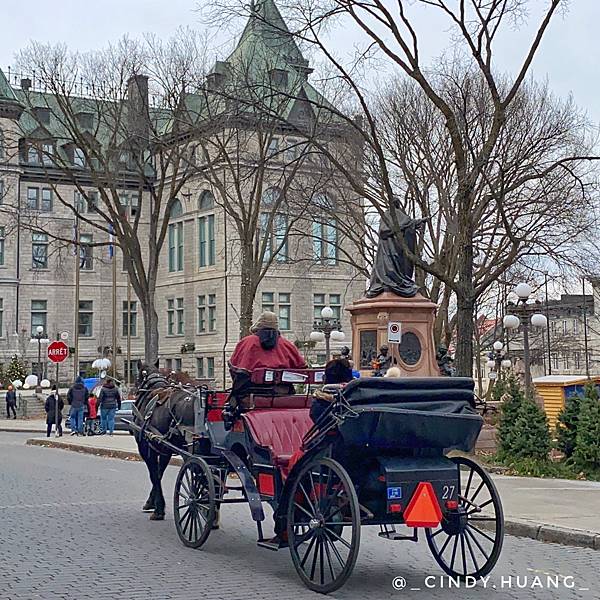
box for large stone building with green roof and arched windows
[0,0,365,383]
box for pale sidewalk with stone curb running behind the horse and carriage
[11,428,600,550]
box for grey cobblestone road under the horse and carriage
[0,433,600,600]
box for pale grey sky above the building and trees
[0,0,600,121]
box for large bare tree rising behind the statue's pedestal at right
[209,0,595,375]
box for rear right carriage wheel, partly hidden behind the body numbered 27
[425,457,504,578]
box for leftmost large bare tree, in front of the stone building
[8,30,211,362]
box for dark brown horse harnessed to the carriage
[133,361,194,521]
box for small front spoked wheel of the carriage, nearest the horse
[173,457,217,548]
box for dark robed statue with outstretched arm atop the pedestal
[367,202,427,298]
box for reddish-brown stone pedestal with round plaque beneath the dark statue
[346,292,440,377]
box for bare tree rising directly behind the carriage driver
[188,14,358,336]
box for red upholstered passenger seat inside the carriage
[242,408,313,474]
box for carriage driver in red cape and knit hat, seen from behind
[229,310,306,409]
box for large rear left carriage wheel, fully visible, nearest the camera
[287,458,360,594]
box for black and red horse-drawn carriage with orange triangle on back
[130,369,504,593]
